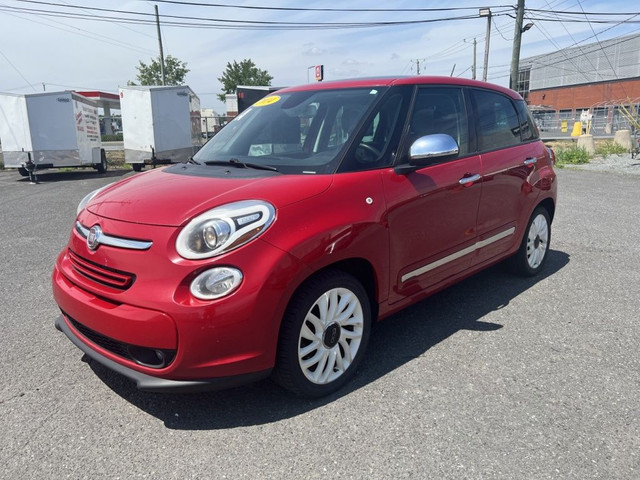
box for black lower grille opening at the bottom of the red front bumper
[65,313,176,368]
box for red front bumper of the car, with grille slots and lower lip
[52,211,306,391]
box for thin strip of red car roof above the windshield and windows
[278,76,522,100]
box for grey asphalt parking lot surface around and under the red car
[0,166,640,479]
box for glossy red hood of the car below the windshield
[86,165,332,227]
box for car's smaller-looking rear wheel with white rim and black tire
[509,207,551,277]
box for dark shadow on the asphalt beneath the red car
[90,250,570,430]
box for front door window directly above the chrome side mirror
[409,87,469,156]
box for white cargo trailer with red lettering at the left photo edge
[0,91,107,176]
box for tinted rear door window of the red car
[473,90,521,151]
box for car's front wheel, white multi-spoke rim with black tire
[273,270,371,398]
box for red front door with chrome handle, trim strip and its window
[384,86,482,303]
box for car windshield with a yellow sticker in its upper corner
[194,87,385,174]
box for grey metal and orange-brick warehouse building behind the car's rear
[518,34,640,134]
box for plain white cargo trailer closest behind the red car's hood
[120,85,202,171]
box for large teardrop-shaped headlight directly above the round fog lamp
[176,200,275,260]
